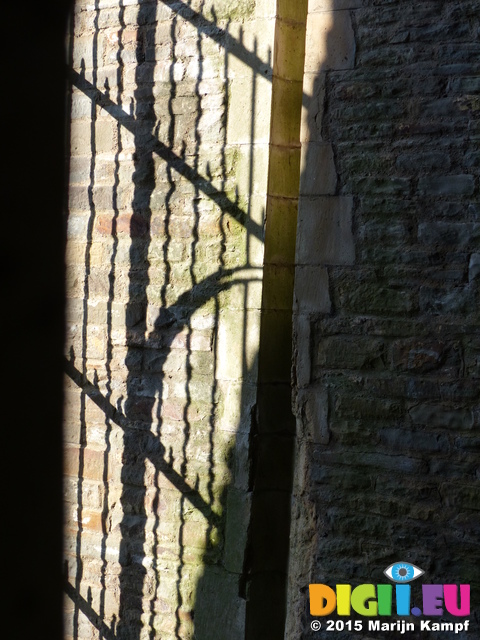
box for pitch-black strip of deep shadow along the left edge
[1,2,70,640]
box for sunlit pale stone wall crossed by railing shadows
[66,0,270,640]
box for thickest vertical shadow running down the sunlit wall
[117,2,157,640]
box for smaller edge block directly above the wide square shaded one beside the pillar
[300,140,337,196]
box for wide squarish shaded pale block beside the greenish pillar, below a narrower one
[296,196,355,265]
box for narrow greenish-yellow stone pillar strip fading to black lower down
[246,0,307,640]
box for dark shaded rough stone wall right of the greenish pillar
[286,0,480,638]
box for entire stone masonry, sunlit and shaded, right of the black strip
[64,0,480,640]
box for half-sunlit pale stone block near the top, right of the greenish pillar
[305,10,355,73]
